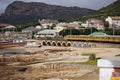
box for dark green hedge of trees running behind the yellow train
[59,28,120,36]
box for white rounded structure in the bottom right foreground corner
[97,57,120,80]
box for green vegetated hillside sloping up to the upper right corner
[79,0,120,20]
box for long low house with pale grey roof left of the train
[34,29,59,38]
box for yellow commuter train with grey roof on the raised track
[65,35,120,43]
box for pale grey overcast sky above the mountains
[0,0,116,13]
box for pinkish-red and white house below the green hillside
[86,19,104,30]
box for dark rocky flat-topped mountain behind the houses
[0,1,95,24]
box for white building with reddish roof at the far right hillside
[105,16,120,28]
